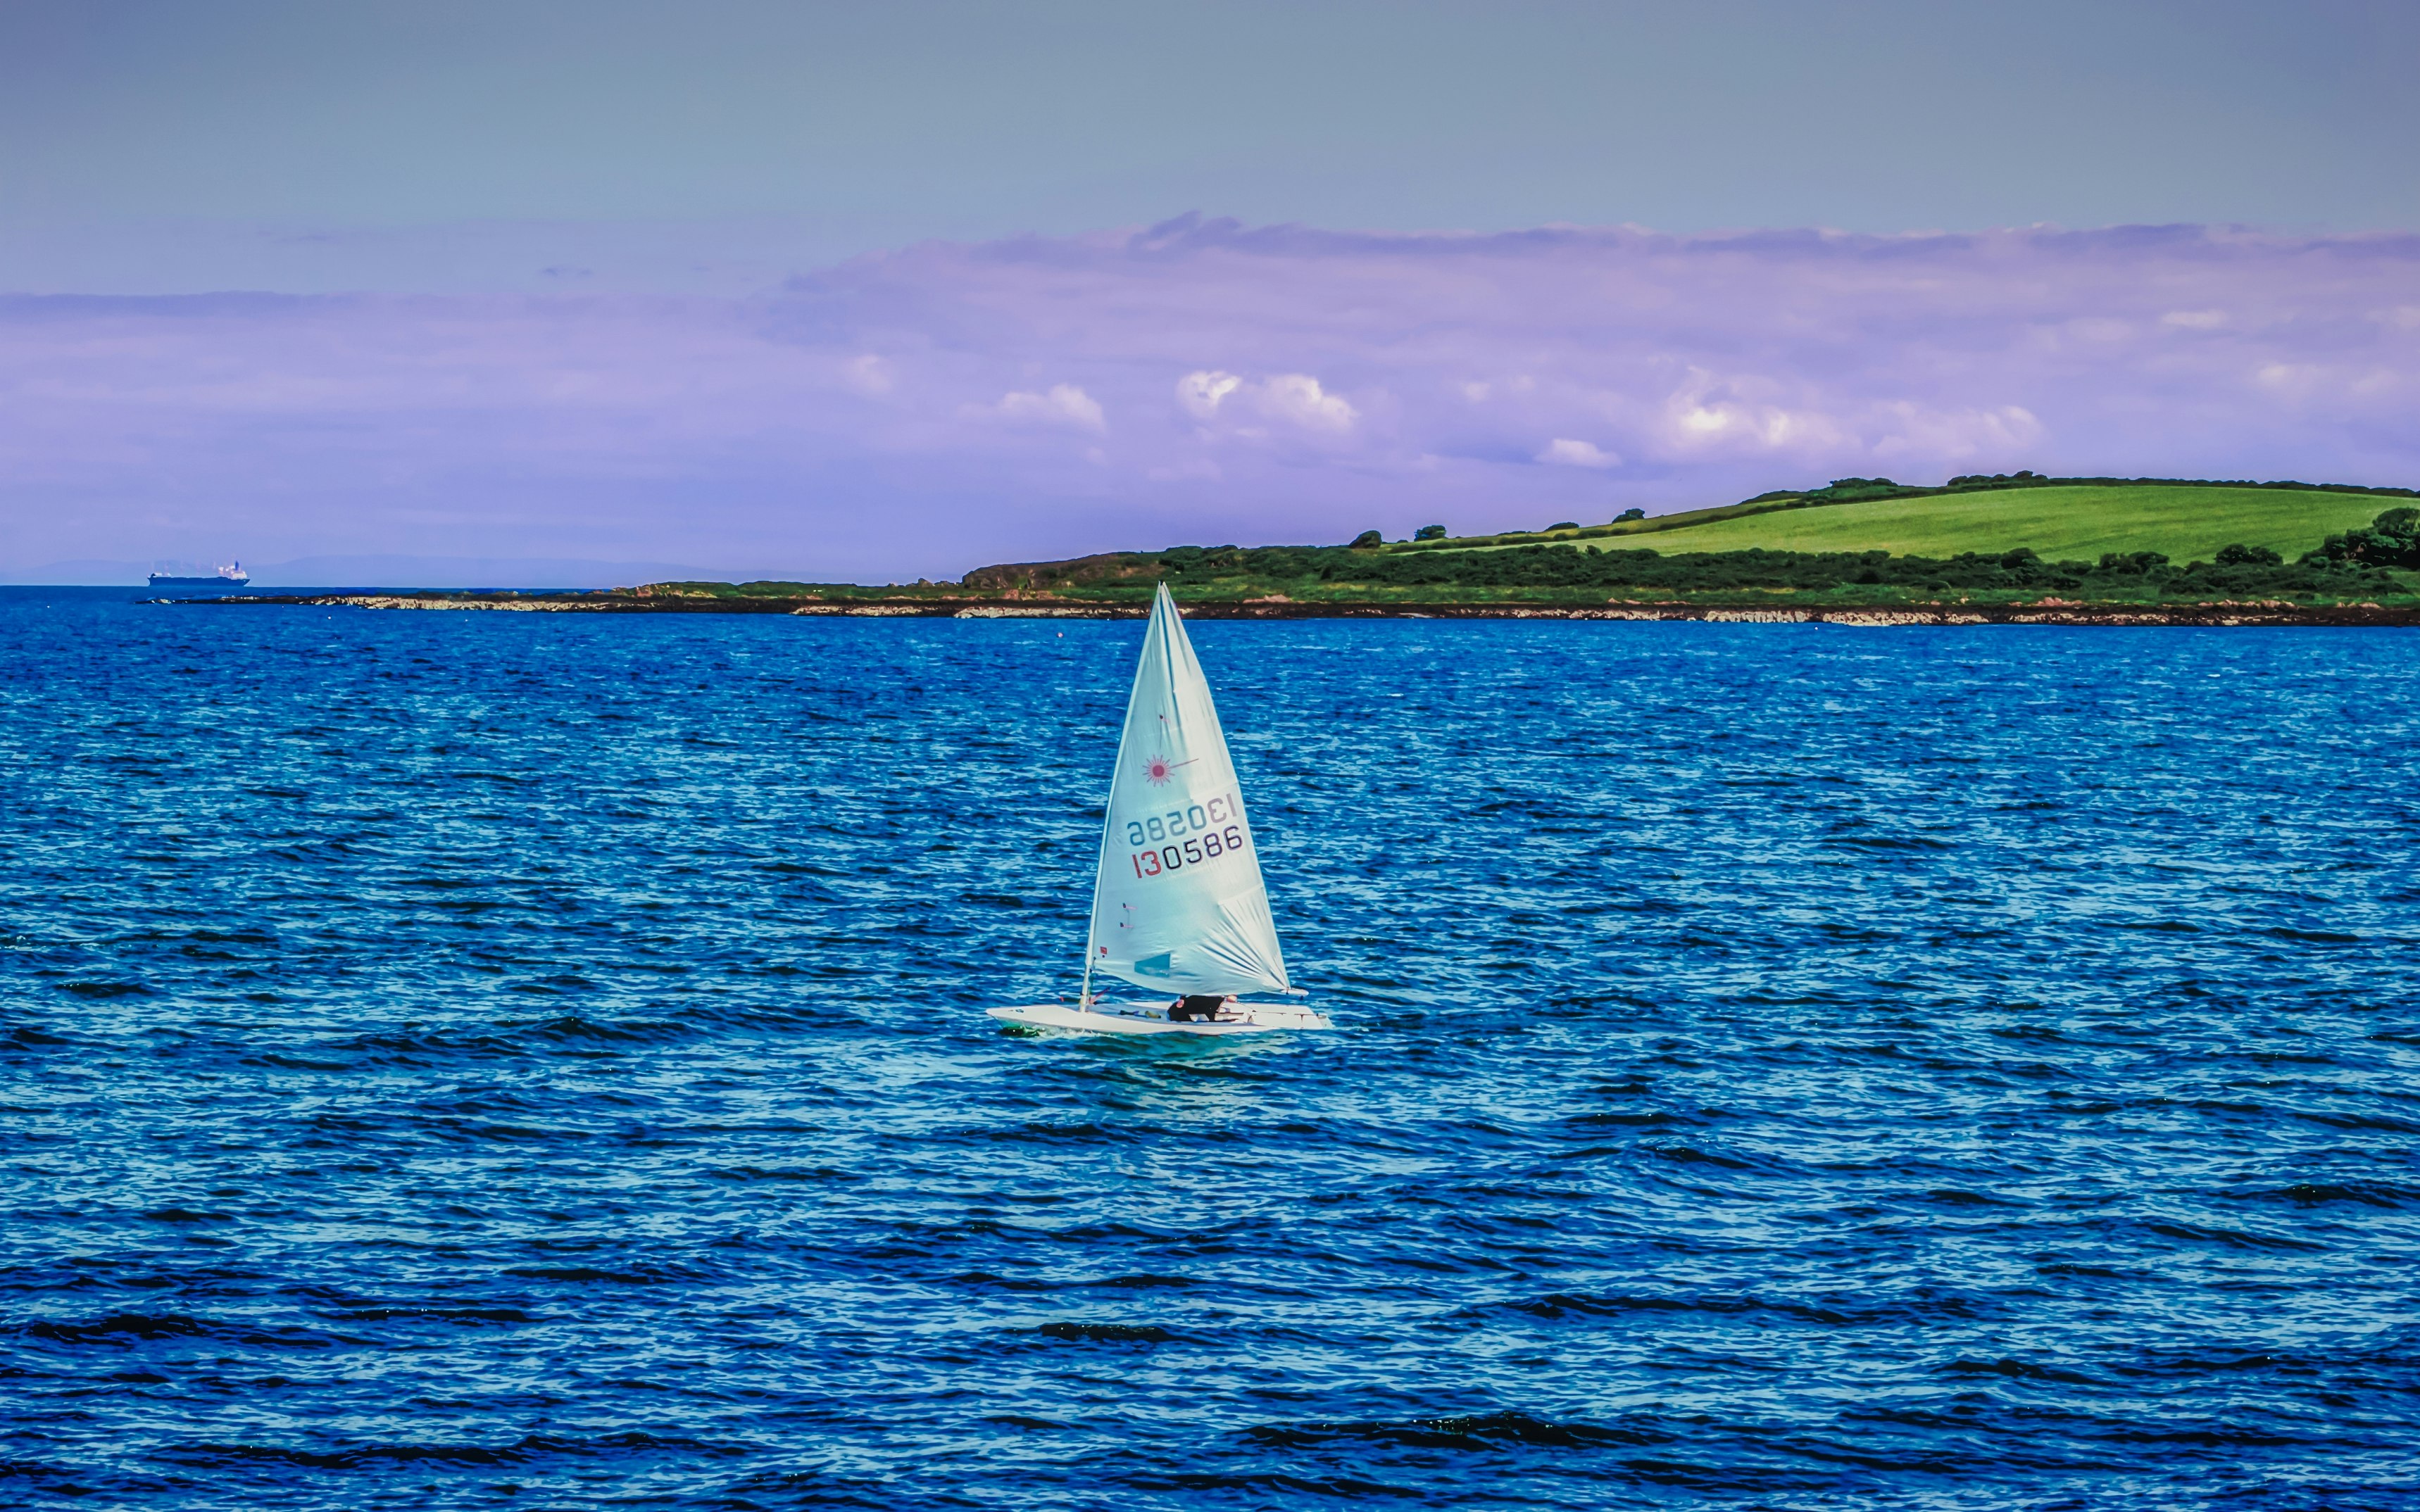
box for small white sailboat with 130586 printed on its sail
[985,583,1336,1035]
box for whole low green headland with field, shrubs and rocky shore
[196,472,2420,624]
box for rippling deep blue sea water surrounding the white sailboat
[0,591,2420,1510]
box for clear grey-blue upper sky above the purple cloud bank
[0,0,2420,293]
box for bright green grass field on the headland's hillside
[1529,486,2405,564]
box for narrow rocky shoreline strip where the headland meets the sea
[184,593,2420,626]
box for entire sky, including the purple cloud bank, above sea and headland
[0,0,2420,578]
